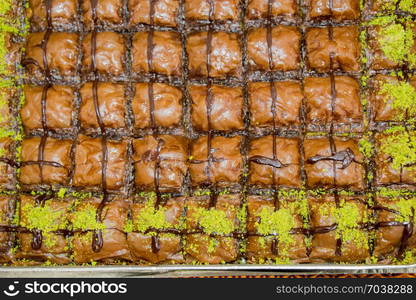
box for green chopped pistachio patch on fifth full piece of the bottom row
[256,207,295,245]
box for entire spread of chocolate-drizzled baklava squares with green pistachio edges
[0,0,416,268]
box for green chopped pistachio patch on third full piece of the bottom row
[133,200,172,232]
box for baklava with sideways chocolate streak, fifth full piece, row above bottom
[248,136,301,187]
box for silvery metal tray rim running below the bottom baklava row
[0,264,416,278]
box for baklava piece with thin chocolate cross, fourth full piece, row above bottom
[189,136,243,186]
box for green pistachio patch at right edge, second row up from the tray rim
[380,126,416,170]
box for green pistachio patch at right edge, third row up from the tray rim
[380,81,416,121]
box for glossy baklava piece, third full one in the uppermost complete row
[132,31,182,76]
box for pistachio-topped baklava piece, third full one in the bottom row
[127,197,185,264]
